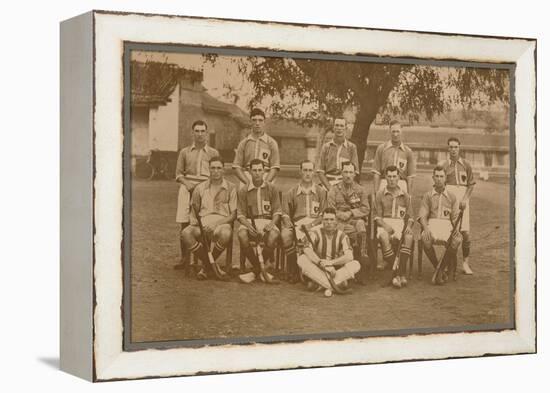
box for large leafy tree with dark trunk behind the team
[209,57,509,172]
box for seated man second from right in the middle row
[374,165,414,288]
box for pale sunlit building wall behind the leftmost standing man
[149,83,179,151]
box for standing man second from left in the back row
[233,108,281,187]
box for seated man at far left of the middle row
[181,157,237,280]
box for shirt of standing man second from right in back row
[372,141,416,180]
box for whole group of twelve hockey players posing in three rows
[176,108,475,289]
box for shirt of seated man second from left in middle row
[237,182,282,219]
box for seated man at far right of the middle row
[418,166,462,284]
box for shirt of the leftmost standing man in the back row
[176,144,220,182]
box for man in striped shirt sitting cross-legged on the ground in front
[298,207,361,296]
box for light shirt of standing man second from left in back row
[233,133,281,170]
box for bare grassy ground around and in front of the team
[131,175,512,342]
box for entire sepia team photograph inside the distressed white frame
[125,48,515,346]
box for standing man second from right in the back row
[372,120,416,195]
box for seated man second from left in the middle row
[237,159,282,283]
